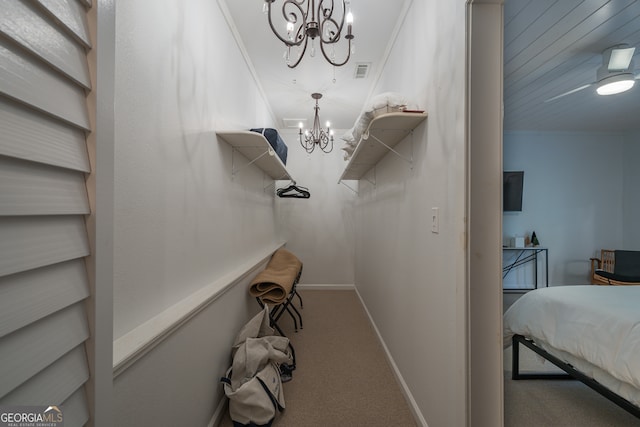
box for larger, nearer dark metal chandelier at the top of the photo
[263,0,354,68]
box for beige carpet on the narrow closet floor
[220,290,416,427]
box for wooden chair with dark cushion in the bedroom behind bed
[590,249,640,285]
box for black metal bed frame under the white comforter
[511,334,640,418]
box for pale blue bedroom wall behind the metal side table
[503,132,640,285]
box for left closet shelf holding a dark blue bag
[216,130,293,181]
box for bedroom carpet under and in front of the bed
[504,346,640,427]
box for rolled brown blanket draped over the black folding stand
[249,249,302,304]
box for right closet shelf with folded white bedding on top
[339,112,427,181]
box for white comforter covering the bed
[504,285,640,404]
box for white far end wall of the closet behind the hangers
[276,129,355,285]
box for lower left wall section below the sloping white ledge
[112,277,257,427]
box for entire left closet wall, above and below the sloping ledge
[110,0,281,426]
